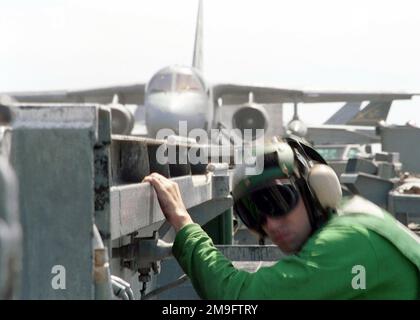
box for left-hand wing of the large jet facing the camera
[5,84,145,105]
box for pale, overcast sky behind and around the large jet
[0,0,420,124]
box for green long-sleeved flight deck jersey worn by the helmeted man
[173,197,420,299]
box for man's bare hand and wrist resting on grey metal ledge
[143,172,193,232]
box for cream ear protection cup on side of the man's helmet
[308,164,342,209]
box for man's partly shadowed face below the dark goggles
[262,197,311,253]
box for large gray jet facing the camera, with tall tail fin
[2,0,412,138]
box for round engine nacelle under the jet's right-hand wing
[232,104,268,140]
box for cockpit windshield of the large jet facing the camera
[148,70,205,93]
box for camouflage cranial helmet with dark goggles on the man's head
[232,138,334,236]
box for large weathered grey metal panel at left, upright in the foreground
[11,106,97,299]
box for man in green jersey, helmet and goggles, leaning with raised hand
[144,139,420,299]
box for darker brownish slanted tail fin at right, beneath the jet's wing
[347,101,392,126]
